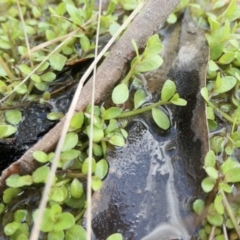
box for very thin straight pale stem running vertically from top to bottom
[87,0,102,240]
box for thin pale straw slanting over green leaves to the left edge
[0,31,76,103]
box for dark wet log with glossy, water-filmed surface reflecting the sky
[89,11,209,240]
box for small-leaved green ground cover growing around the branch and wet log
[0,0,240,240]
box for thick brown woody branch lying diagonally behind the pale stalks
[0,0,180,191]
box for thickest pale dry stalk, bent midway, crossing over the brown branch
[30,1,145,240]
